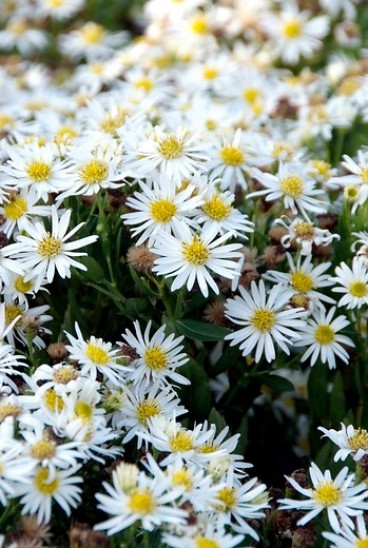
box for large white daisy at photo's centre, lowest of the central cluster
[151,223,243,297]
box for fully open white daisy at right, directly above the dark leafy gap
[225,280,305,362]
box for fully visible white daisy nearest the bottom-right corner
[279,462,368,533]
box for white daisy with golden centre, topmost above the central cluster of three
[129,126,208,184]
